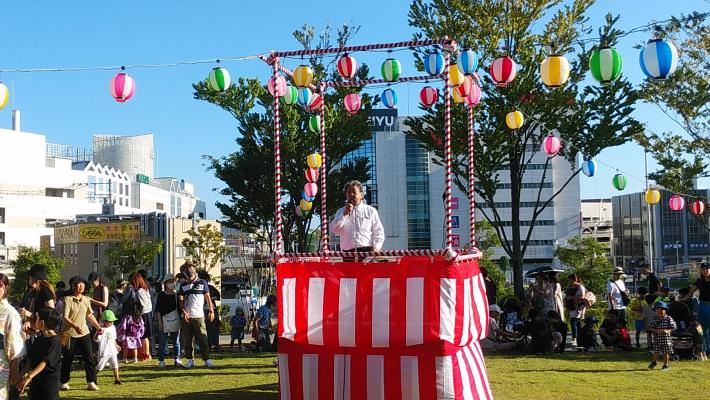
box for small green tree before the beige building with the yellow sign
[105,239,164,281]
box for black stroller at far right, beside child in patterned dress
[668,301,703,360]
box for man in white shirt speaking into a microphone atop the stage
[331,181,385,258]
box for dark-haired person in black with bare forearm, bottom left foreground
[17,308,62,400]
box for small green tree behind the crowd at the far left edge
[10,246,66,301]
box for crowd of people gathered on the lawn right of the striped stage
[481,263,710,371]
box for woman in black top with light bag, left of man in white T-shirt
[155,274,182,368]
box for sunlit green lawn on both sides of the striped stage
[60,352,710,400]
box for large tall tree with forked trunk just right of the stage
[407,0,642,298]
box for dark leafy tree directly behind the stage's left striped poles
[193,25,375,251]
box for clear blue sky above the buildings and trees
[0,0,710,218]
